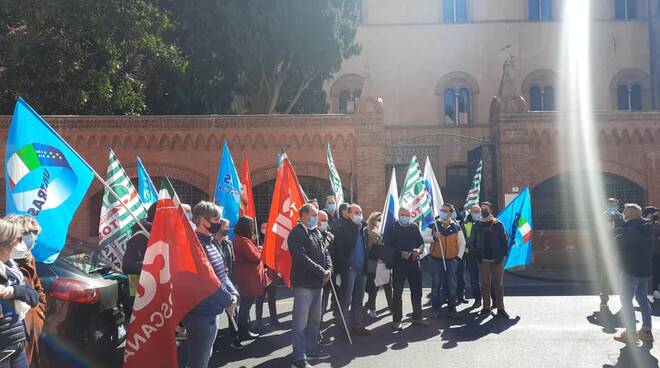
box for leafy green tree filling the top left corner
[0,0,186,114]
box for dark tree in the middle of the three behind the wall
[148,0,239,114]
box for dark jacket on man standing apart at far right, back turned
[615,218,654,277]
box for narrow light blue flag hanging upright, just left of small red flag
[214,141,241,239]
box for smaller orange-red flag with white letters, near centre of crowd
[261,156,305,287]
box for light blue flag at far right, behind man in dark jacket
[497,188,532,269]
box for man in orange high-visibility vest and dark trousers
[429,203,465,319]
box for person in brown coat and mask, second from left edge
[6,215,46,367]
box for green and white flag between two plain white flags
[399,156,433,229]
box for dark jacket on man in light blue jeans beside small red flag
[287,224,332,289]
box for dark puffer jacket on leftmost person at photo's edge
[0,264,39,351]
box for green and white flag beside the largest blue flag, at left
[99,149,147,269]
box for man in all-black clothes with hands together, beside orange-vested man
[384,207,429,330]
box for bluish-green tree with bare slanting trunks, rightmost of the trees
[220,0,360,114]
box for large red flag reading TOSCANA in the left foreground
[123,190,220,368]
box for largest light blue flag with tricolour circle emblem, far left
[5,97,94,263]
